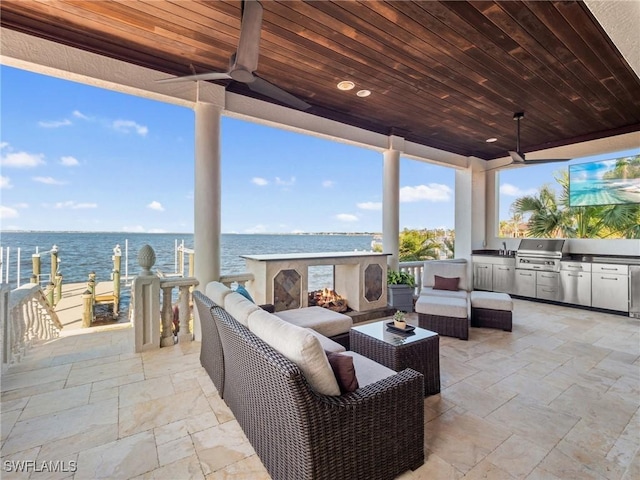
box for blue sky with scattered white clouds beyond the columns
[0,66,636,233]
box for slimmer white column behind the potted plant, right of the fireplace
[382,149,400,270]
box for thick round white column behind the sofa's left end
[193,102,222,340]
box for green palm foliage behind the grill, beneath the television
[513,171,640,238]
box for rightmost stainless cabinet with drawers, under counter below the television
[591,263,629,312]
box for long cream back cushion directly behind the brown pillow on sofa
[249,310,340,395]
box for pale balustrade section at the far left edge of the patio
[0,284,62,370]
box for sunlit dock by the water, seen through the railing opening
[54,281,129,333]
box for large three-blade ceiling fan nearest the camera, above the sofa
[158,0,311,110]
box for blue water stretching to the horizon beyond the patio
[0,232,373,294]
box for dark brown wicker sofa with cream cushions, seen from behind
[194,284,424,480]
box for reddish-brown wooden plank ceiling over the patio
[0,0,640,159]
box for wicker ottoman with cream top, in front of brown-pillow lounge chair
[416,295,469,340]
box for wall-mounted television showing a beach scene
[569,155,640,207]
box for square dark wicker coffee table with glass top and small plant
[349,320,440,396]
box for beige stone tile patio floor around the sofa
[1,300,640,480]
